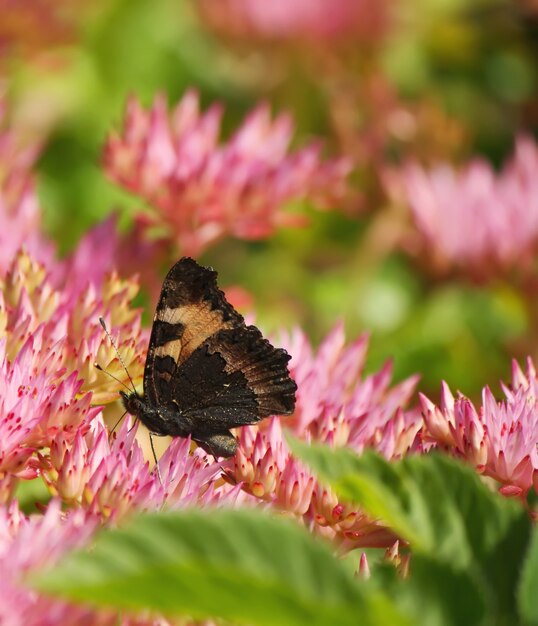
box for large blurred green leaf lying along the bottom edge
[33,509,409,626]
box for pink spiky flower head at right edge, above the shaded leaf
[421,360,538,497]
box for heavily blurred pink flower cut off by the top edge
[196,0,389,42]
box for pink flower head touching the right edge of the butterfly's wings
[282,323,422,458]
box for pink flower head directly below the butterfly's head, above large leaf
[40,420,230,521]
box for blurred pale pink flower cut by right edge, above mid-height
[385,137,538,277]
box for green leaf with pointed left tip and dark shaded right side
[290,441,530,624]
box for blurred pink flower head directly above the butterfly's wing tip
[104,91,350,256]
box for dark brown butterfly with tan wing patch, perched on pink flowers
[120,257,297,457]
